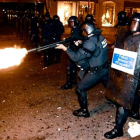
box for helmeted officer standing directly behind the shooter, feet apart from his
[61,16,83,90]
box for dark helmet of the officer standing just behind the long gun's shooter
[68,16,79,28]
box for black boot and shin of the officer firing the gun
[73,87,90,118]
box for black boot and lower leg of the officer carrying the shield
[104,107,129,139]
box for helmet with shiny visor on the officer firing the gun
[81,21,96,37]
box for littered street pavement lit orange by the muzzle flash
[0,20,140,140]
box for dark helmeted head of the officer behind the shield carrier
[114,11,128,27]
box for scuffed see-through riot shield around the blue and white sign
[105,36,140,109]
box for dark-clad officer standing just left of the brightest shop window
[52,15,64,63]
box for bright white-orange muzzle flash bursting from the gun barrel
[0,47,27,69]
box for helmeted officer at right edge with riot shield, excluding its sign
[104,13,140,139]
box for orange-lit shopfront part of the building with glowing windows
[47,0,140,27]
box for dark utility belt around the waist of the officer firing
[88,61,109,74]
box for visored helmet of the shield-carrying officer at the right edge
[131,13,140,33]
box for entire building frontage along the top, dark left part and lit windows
[0,0,140,27]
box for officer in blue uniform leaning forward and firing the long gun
[57,21,109,117]
